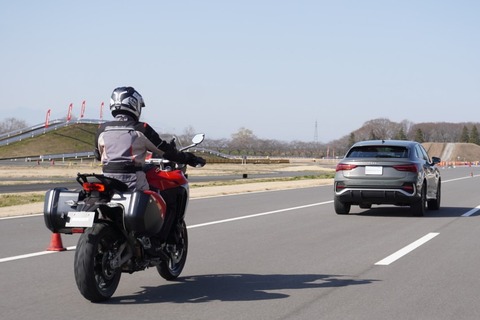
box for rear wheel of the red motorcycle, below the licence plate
[74,223,122,302]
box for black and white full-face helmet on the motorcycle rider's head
[110,87,145,120]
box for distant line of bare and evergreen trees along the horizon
[0,118,480,158]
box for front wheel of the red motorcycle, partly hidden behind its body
[157,221,188,281]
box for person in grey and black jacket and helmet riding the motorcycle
[95,87,206,242]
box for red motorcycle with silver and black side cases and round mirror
[44,134,205,302]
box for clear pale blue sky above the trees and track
[0,0,480,142]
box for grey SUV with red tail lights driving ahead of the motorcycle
[334,140,441,216]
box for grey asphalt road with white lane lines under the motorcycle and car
[0,168,480,320]
